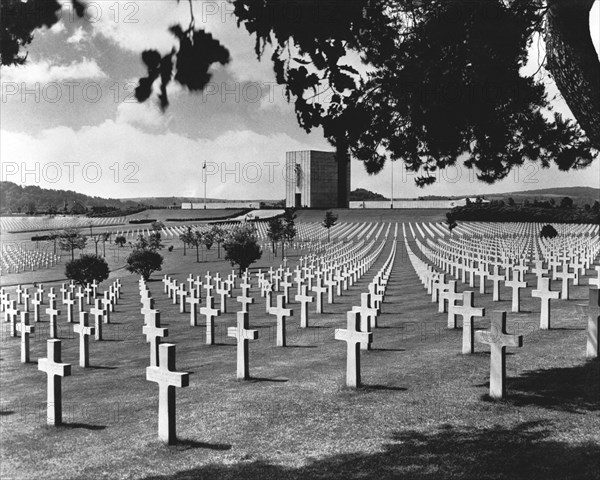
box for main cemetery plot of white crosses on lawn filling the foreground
[0,218,600,479]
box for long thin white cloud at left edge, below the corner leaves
[1,58,106,84]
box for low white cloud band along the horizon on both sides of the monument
[0,120,600,199]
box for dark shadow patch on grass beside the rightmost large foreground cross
[507,360,600,413]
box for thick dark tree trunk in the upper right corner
[546,0,600,149]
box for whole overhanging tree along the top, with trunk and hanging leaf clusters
[2,0,600,186]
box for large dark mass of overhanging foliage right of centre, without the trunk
[229,0,599,186]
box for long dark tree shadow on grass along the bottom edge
[146,422,600,480]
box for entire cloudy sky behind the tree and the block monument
[0,0,600,199]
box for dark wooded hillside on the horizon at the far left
[0,182,138,213]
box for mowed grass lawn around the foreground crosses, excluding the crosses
[0,224,600,480]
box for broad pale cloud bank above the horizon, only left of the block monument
[0,124,310,199]
